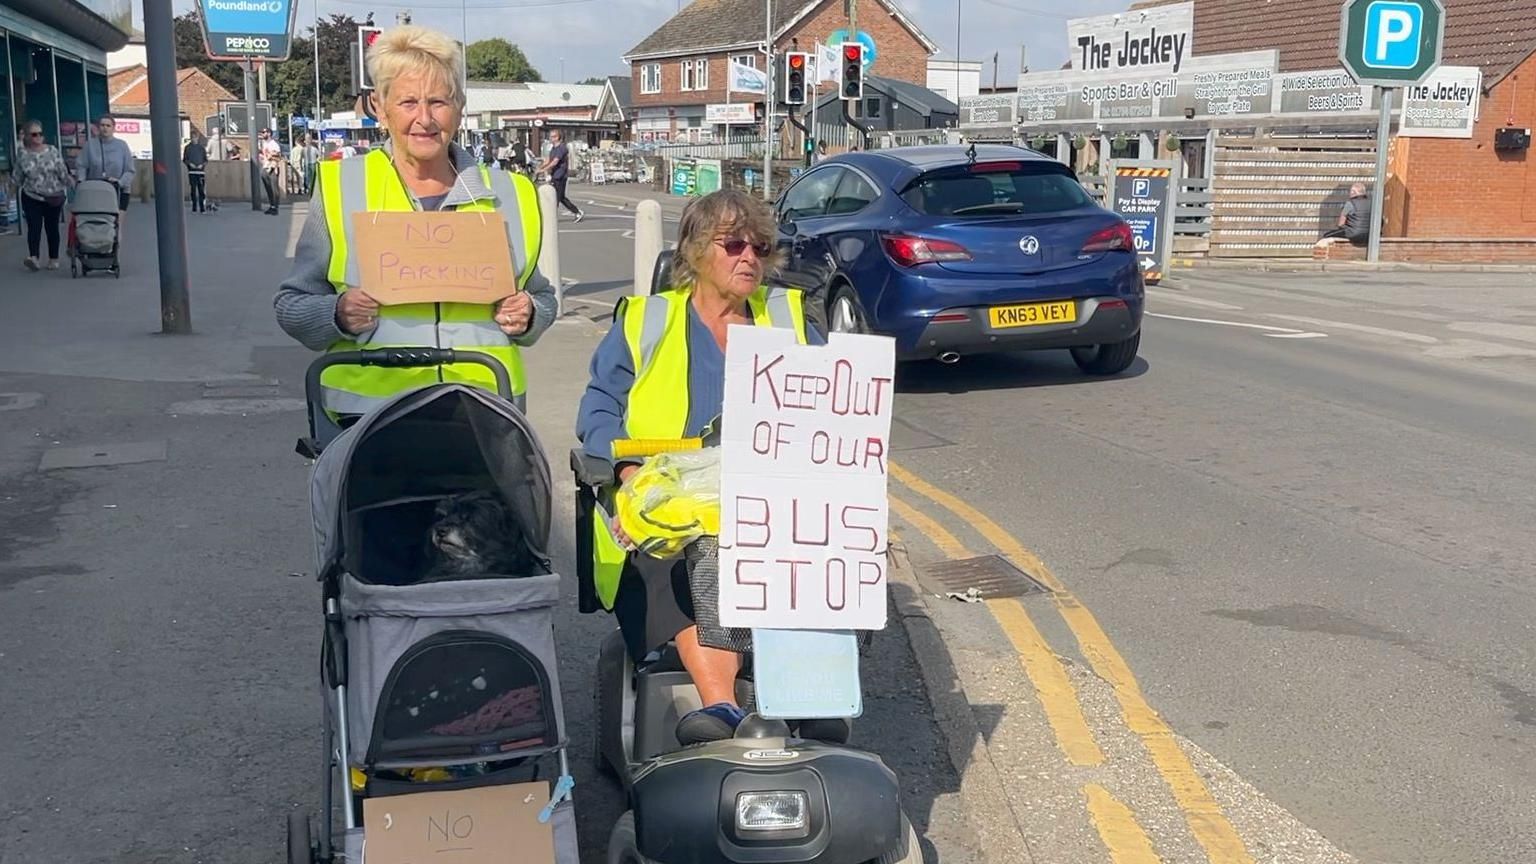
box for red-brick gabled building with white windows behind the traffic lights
[624,0,937,141]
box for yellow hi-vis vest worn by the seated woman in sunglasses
[591,286,806,610]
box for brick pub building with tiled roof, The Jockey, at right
[1130,0,1536,261]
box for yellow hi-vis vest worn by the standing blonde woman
[318,149,544,414]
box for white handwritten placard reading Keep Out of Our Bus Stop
[720,326,895,630]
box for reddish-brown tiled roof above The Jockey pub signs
[1132,0,1536,86]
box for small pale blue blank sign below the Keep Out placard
[753,629,863,719]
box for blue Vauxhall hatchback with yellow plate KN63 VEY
[776,145,1146,375]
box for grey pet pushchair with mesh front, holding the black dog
[289,349,578,864]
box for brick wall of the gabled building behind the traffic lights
[630,0,928,108]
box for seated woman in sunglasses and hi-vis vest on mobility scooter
[576,189,823,744]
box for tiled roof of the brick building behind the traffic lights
[625,0,937,58]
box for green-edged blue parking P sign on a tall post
[1339,0,1445,88]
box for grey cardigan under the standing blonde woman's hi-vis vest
[272,143,559,351]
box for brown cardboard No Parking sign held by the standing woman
[352,211,518,306]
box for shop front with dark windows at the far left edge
[0,0,132,231]
